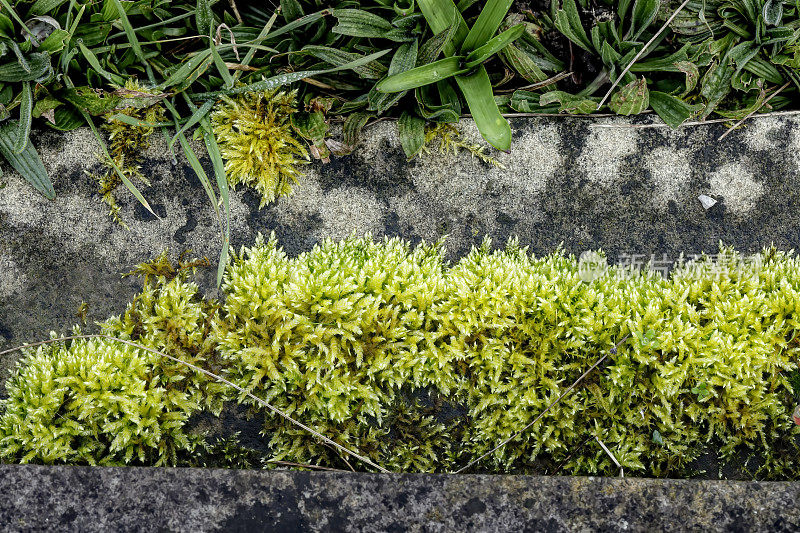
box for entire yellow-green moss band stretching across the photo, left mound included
[0,236,800,479]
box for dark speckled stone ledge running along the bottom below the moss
[0,465,800,531]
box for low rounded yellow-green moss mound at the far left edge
[0,339,200,465]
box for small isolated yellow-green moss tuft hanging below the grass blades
[211,90,308,207]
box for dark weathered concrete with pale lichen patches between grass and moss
[0,117,800,379]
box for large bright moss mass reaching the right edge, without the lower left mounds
[215,238,800,475]
